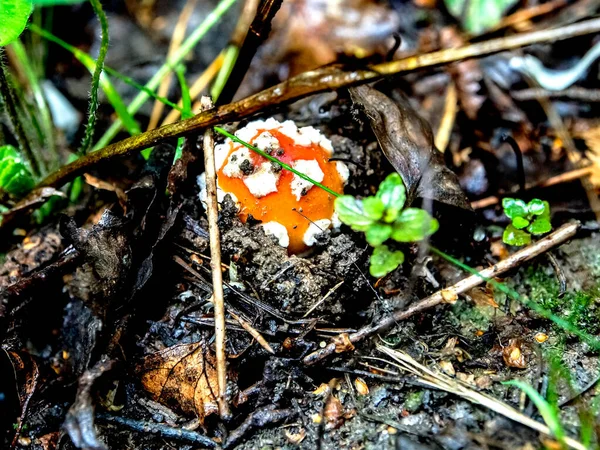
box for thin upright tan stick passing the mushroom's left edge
[204,97,231,419]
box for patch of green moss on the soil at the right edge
[524,266,600,334]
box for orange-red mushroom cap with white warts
[201,118,348,253]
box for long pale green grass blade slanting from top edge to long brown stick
[94,0,236,150]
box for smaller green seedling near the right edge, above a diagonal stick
[502,198,552,246]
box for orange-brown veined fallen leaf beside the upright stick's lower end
[138,342,227,423]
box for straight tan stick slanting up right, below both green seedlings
[303,223,579,365]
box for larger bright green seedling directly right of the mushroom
[335,173,439,277]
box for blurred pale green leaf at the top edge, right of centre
[444,0,517,34]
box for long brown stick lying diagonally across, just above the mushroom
[40,18,600,187]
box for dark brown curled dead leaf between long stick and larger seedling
[349,86,471,211]
